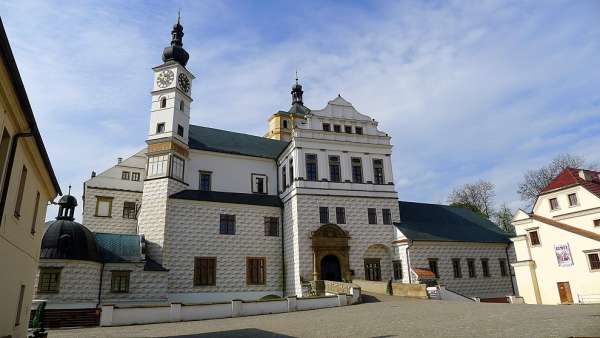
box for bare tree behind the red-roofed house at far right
[517,154,594,207]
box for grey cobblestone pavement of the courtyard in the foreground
[49,296,600,338]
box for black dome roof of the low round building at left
[40,219,100,262]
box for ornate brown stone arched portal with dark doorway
[311,224,352,281]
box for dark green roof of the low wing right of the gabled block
[396,201,510,243]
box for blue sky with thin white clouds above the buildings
[0,0,600,218]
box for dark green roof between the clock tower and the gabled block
[188,125,289,160]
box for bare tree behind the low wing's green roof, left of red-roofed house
[448,180,496,218]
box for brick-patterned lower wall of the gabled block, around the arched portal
[286,195,400,288]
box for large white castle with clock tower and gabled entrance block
[32,17,512,326]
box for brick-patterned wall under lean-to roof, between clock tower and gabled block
[164,199,283,293]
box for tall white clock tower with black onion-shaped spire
[138,16,194,267]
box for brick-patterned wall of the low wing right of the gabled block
[410,243,513,298]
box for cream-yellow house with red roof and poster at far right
[512,168,600,304]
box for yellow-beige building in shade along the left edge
[0,20,60,337]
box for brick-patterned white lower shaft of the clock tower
[138,178,187,263]
